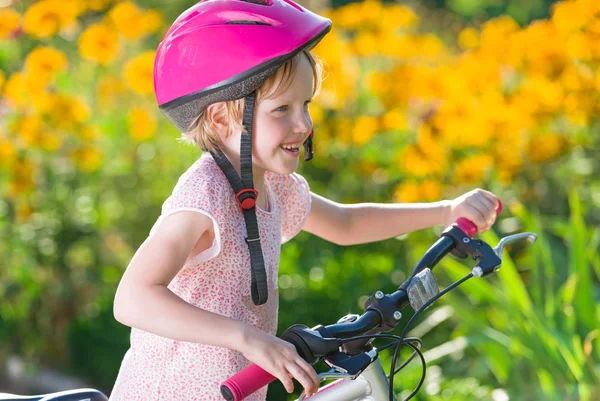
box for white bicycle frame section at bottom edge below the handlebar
[296,358,396,401]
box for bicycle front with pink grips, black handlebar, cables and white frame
[221,204,537,401]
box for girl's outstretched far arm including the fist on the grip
[303,189,498,245]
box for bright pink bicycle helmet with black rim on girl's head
[154,0,331,132]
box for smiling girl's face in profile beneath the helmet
[252,55,313,174]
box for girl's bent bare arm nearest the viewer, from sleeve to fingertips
[114,211,319,394]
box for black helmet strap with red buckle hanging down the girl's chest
[211,92,268,305]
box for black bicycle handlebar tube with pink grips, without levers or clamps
[221,200,502,401]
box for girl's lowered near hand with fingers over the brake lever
[239,326,319,397]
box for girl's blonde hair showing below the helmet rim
[181,50,323,152]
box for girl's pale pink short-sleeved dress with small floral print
[110,153,310,401]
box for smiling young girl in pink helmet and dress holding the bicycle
[111,0,498,401]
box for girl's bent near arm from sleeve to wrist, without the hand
[114,211,243,348]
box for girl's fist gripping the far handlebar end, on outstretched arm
[443,188,499,232]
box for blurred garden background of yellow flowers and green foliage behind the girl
[0,0,600,401]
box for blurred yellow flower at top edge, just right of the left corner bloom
[23,0,79,38]
